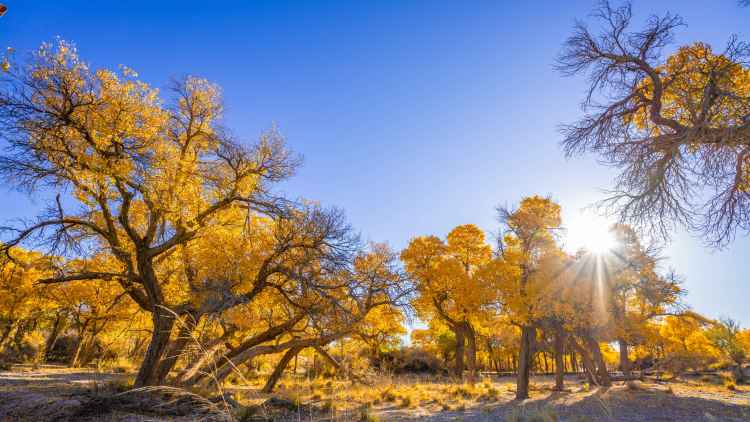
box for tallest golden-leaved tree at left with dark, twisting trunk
[0,41,298,386]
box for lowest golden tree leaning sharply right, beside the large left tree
[182,245,408,389]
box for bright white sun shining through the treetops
[565,214,616,255]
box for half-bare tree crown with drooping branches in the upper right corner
[558,2,750,246]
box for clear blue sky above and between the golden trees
[0,0,750,325]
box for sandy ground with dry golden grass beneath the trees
[0,366,750,422]
